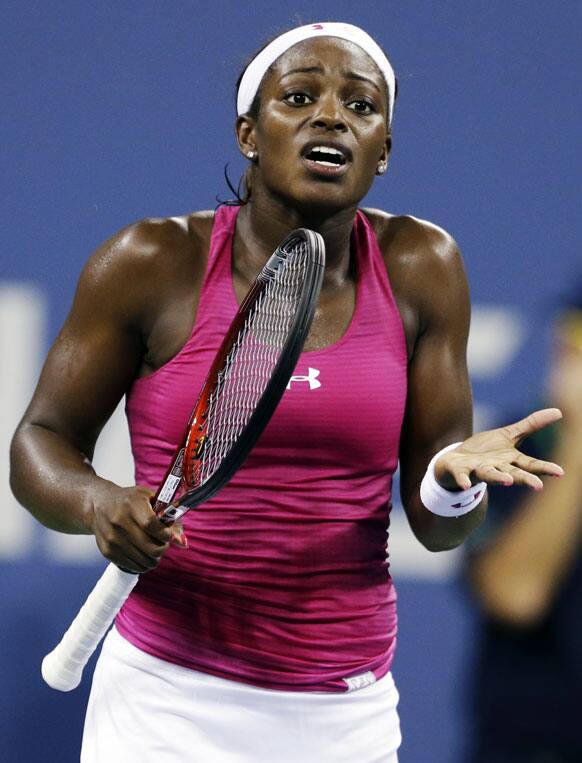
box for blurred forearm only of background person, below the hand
[472,438,582,624]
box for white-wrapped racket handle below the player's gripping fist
[41,564,139,691]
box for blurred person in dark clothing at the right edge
[467,293,582,763]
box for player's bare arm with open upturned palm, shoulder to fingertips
[377,212,561,551]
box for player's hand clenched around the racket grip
[90,484,184,573]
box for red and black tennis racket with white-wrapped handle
[42,228,325,691]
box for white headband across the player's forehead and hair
[236,23,396,122]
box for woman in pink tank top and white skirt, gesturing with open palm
[12,24,561,763]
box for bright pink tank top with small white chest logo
[117,207,407,691]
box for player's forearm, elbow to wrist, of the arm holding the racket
[10,423,114,534]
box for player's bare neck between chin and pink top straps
[234,191,356,287]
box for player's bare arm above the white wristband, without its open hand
[400,221,485,551]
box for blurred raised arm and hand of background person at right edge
[470,332,582,627]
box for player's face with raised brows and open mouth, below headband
[238,37,390,212]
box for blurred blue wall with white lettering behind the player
[0,0,582,763]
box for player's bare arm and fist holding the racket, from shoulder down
[11,218,195,571]
